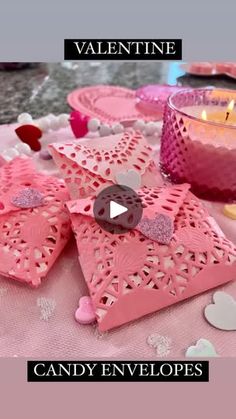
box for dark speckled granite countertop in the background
[0,61,236,124]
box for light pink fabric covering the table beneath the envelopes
[0,122,236,359]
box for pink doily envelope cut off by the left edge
[0,158,71,287]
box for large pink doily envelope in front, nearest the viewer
[67,184,236,331]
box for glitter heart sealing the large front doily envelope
[139,214,174,244]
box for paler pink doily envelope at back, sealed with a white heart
[49,130,160,199]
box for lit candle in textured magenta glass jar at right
[160,88,236,201]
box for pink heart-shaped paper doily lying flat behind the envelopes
[67,85,162,123]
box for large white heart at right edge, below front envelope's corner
[204,291,236,330]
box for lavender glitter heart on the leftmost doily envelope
[11,188,44,209]
